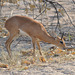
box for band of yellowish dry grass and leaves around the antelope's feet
[0,47,75,70]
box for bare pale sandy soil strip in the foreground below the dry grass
[0,60,75,75]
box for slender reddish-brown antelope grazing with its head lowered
[5,16,65,57]
